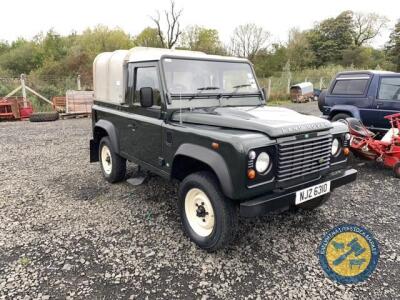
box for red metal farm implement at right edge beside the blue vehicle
[346,113,400,178]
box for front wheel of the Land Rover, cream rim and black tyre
[179,172,238,252]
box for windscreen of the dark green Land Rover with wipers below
[163,58,259,96]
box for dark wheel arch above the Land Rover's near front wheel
[171,144,233,198]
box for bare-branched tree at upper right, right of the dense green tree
[352,13,389,47]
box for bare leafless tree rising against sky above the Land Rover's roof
[151,0,182,49]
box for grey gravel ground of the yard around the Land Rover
[0,103,400,299]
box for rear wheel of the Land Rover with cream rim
[99,136,126,183]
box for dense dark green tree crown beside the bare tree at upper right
[308,11,353,66]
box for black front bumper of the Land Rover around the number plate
[240,169,357,217]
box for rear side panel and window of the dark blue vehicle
[327,74,374,126]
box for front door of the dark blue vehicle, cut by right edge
[376,75,400,128]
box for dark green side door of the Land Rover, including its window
[125,62,164,166]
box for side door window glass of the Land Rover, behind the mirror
[134,67,161,106]
